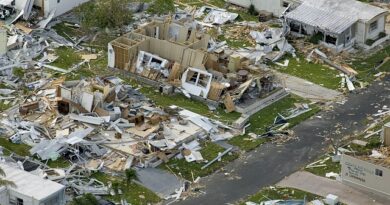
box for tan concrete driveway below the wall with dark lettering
[277,171,389,205]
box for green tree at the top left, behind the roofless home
[75,0,132,30]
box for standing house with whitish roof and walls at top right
[285,0,388,52]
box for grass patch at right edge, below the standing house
[350,45,390,82]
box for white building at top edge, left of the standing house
[228,0,285,16]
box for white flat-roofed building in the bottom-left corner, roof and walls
[0,164,65,205]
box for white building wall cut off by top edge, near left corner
[44,0,89,17]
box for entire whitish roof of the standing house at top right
[286,0,386,34]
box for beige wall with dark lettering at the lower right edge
[341,155,390,196]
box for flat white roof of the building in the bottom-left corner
[0,163,65,200]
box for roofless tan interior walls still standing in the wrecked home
[108,18,209,71]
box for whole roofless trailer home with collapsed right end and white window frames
[108,19,287,115]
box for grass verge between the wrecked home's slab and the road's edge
[229,95,320,151]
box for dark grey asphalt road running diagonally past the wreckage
[176,76,390,205]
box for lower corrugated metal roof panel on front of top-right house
[286,4,358,34]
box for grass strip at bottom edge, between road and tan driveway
[240,187,322,205]
